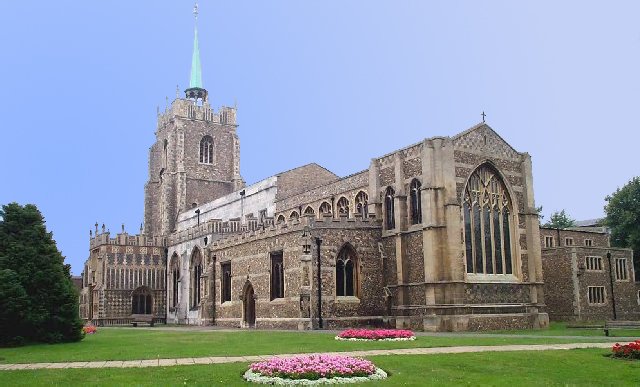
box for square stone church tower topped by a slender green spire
[144,3,244,235]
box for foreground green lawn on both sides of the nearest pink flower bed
[0,349,640,386]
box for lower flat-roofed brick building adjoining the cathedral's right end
[540,227,640,321]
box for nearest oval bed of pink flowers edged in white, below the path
[243,354,387,385]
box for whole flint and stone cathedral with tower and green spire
[80,5,633,331]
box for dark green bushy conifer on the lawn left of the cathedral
[0,203,82,343]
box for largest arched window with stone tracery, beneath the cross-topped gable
[462,164,513,275]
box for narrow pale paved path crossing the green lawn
[0,343,611,371]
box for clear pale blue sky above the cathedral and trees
[0,0,640,274]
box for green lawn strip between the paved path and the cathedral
[0,328,620,363]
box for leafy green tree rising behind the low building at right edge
[604,177,640,281]
